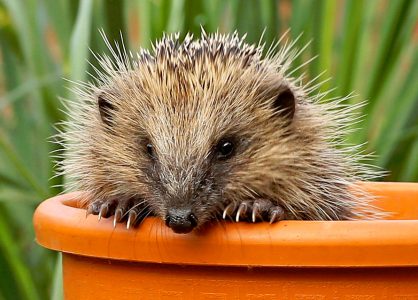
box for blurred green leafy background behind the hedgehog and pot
[0,0,418,299]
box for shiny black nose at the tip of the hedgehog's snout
[165,208,197,233]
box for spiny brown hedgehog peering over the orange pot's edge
[58,29,377,233]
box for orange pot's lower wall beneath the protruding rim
[63,254,418,300]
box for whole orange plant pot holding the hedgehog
[34,183,418,299]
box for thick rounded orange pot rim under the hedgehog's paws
[34,182,418,267]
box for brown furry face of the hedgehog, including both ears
[91,56,295,233]
